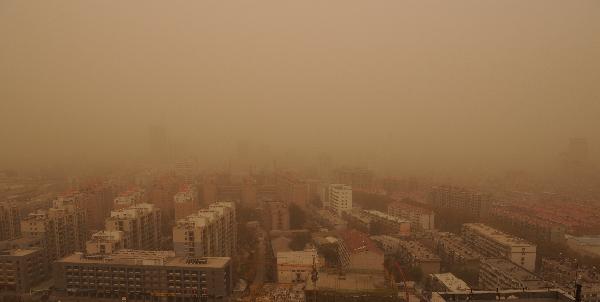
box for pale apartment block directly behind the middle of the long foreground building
[105,203,162,250]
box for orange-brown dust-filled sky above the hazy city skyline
[0,0,600,174]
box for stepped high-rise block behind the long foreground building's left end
[21,197,88,261]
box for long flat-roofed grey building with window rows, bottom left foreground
[54,250,233,302]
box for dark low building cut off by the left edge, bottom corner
[0,248,49,293]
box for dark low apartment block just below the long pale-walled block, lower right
[479,258,548,290]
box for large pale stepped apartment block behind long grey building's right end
[173,202,237,257]
